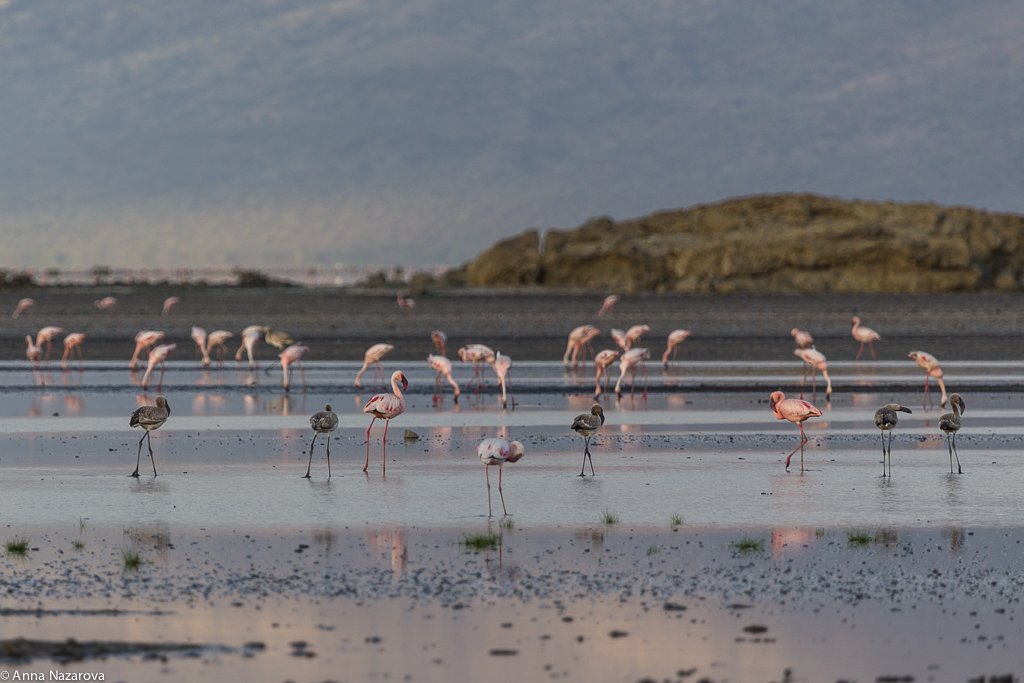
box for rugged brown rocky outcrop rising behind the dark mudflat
[465,195,1024,293]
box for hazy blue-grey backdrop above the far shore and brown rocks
[0,0,1024,268]
